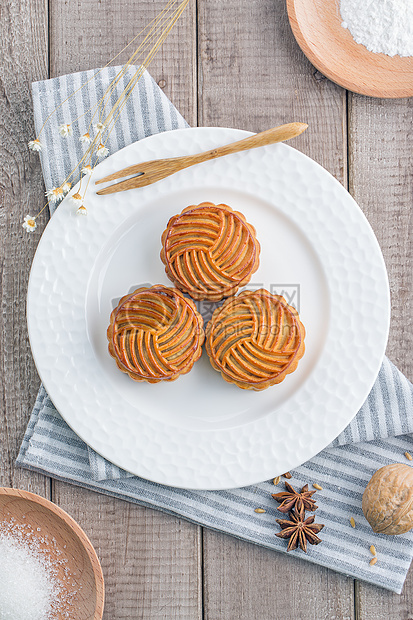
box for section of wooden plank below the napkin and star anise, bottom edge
[204,530,354,620]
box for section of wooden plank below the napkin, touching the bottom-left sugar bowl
[54,483,202,620]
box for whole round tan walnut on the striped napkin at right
[362,463,413,535]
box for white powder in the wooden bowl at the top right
[340,0,413,56]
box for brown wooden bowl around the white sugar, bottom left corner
[0,487,104,620]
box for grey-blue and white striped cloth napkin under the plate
[17,68,413,593]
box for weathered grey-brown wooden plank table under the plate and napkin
[0,0,413,620]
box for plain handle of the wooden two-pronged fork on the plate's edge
[184,123,308,168]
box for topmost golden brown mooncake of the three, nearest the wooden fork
[161,202,260,301]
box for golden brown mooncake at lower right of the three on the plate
[205,289,305,390]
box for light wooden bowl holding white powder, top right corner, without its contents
[287,0,413,98]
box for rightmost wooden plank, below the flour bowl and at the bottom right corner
[349,94,413,620]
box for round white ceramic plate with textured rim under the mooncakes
[28,128,389,489]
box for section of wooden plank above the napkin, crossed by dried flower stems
[50,0,196,125]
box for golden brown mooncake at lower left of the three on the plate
[107,284,204,383]
